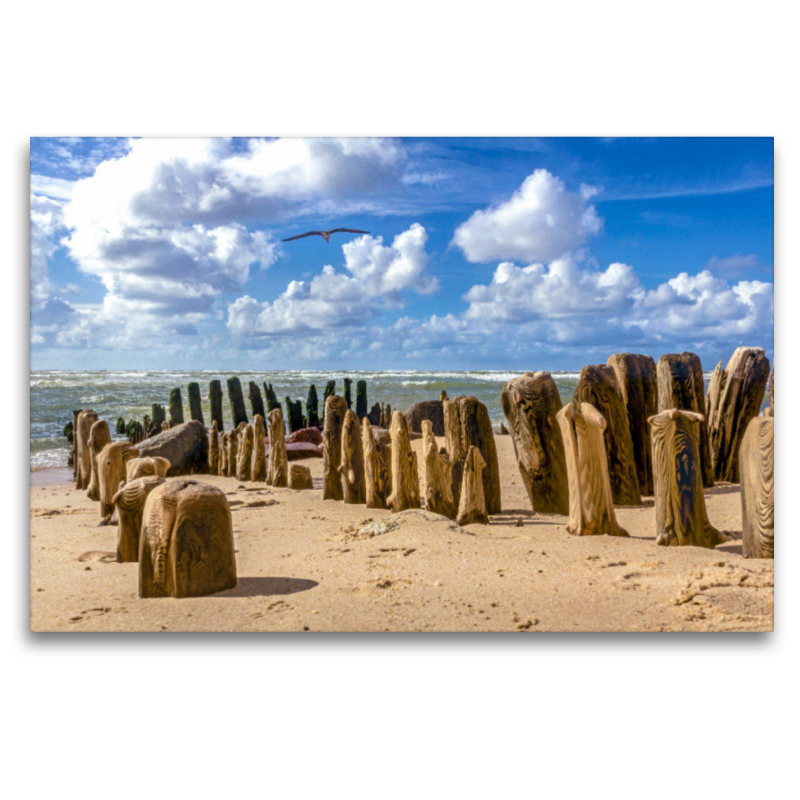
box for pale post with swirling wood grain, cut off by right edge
[739,417,775,558]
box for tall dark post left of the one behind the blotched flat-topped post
[607,353,658,497]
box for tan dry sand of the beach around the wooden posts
[31,436,774,632]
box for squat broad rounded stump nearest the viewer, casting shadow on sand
[139,478,236,597]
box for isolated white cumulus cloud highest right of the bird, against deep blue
[453,169,603,263]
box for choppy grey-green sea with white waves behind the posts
[30,370,744,470]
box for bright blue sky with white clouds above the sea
[30,137,774,371]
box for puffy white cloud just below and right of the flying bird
[228,223,438,337]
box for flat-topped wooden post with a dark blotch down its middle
[649,408,727,548]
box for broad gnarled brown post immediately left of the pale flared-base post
[501,372,569,514]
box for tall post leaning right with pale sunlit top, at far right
[708,347,770,483]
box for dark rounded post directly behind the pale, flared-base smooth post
[572,364,642,506]
